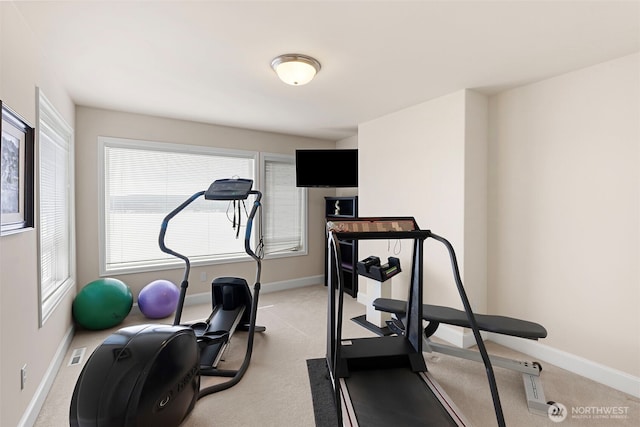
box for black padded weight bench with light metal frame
[373,298,552,416]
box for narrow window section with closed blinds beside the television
[261,154,307,256]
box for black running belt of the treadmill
[344,368,458,427]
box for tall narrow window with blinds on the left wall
[38,90,75,325]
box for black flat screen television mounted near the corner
[296,149,358,187]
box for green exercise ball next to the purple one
[73,278,133,330]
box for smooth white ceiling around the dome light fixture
[16,0,640,139]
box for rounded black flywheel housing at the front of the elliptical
[69,325,200,427]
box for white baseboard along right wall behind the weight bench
[434,325,640,398]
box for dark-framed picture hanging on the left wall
[0,101,35,235]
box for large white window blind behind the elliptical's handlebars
[99,138,256,274]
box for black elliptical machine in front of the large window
[69,178,265,427]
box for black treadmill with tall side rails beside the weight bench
[326,217,505,427]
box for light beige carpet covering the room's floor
[35,286,640,427]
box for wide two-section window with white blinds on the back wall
[98,137,307,275]
